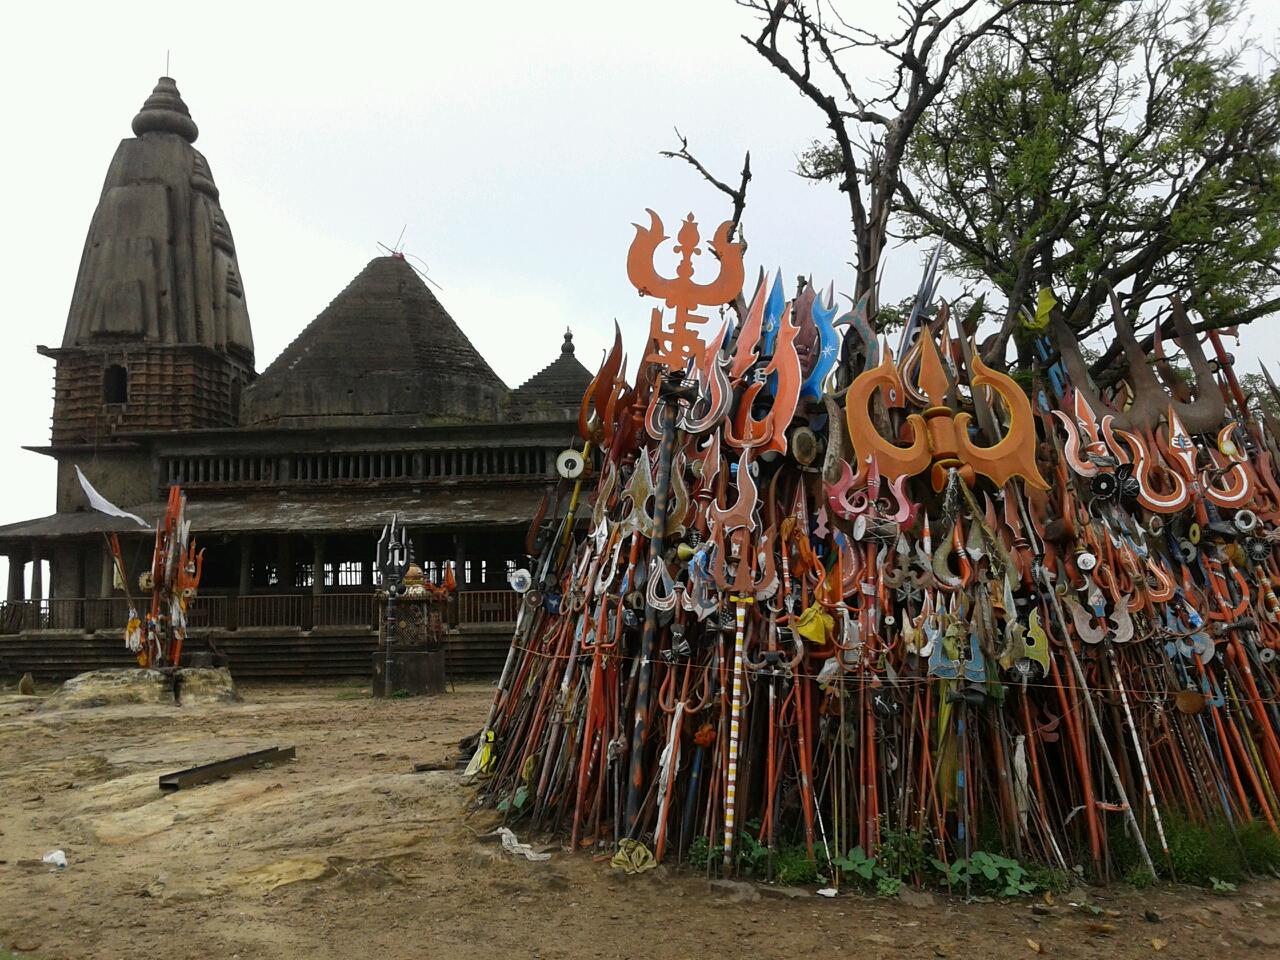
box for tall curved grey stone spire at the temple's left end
[42,77,253,444]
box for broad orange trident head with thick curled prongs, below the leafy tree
[845,334,1048,490]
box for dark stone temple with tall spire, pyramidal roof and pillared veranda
[0,77,591,677]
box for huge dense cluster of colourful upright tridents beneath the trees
[472,211,1280,877]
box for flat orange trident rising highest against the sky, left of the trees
[627,210,744,370]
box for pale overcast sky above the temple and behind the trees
[0,0,1280,593]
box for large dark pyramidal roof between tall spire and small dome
[242,256,507,426]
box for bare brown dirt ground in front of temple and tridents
[0,684,1280,960]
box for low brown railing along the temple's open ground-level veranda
[0,590,520,634]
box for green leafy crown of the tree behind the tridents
[896,0,1280,367]
